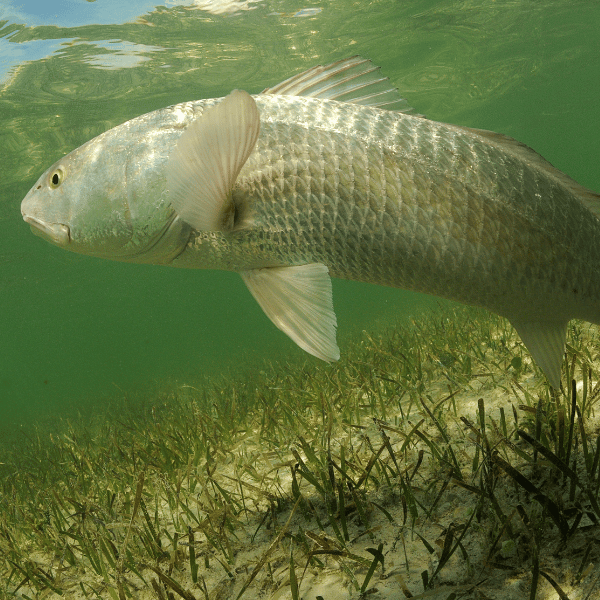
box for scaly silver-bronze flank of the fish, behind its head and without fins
[172,96,600,322]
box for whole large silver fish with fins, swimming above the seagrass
[21,56,600,389]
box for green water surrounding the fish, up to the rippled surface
[0,0,600,441]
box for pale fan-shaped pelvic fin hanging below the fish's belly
[240,264,340,362]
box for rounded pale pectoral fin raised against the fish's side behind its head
[167,90,260,231]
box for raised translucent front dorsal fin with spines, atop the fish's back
[261,56,417,116]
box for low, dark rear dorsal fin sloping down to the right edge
[459,127,600,218]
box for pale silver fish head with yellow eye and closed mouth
[21,128,191,264]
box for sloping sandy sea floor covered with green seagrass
[0,309,600,600]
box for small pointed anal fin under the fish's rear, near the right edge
[510,319,569,390]
